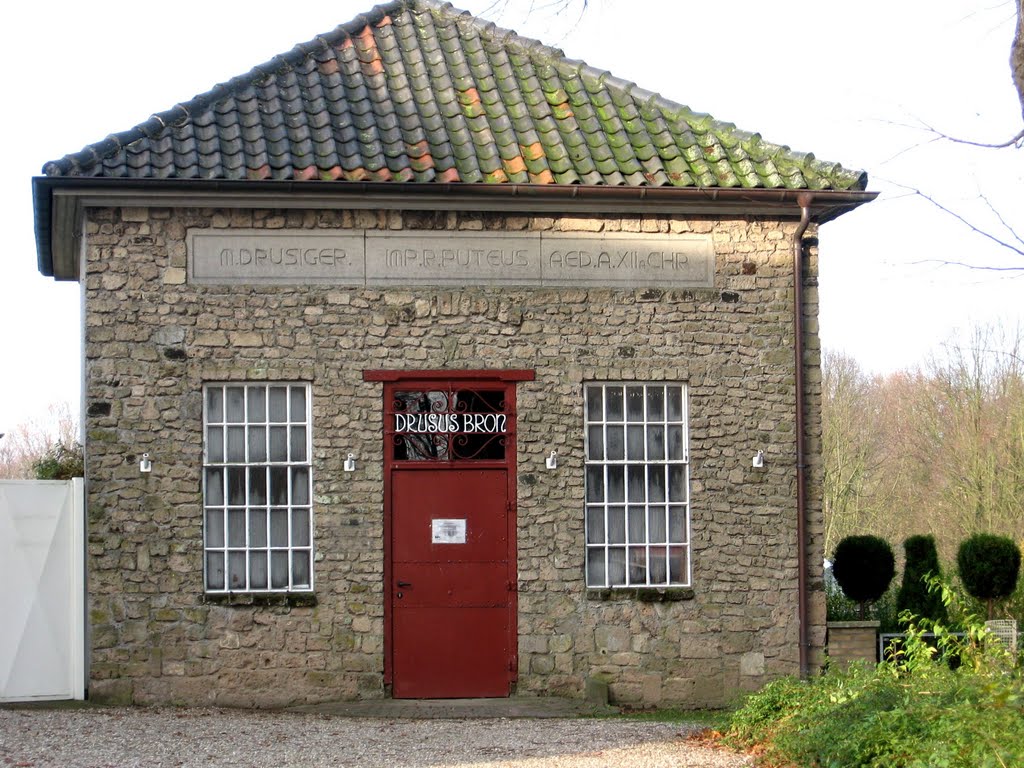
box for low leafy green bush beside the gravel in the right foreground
[726,588,1024,768]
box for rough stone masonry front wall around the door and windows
[84,208,824,707]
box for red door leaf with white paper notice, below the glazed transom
[391,468,514,698]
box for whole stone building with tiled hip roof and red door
[34,0,873,707]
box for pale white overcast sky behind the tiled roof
[0,0,1024,432]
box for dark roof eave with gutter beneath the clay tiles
[33,176,878,280]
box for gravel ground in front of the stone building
[0,709,754,768]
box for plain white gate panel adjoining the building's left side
[0,478,85,701]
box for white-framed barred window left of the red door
[203,382,313,593]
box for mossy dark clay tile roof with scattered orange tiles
[43,0,867,191]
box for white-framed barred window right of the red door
[584,383,690,587]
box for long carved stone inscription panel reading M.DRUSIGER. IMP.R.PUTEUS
[188,229,715,288]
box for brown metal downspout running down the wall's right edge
[793,193,814,677]
